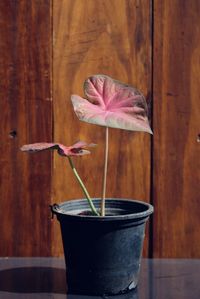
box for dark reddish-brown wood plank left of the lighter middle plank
[0,0,52,256]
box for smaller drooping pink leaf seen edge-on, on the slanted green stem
[21,141,95,156]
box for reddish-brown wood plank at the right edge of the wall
[153,0,200,258]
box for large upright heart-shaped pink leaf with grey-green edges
[71,75,152,134]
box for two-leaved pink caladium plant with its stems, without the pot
[21,75,152,216]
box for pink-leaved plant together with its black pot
[21,75,153,295]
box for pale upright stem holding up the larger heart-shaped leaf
[101,127,108,216]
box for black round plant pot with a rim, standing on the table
[51,199,153,295]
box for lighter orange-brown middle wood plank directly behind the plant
[52,0,151,255]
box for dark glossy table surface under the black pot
[0,258,200,299]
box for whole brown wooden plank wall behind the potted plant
[0,0,200,257]
